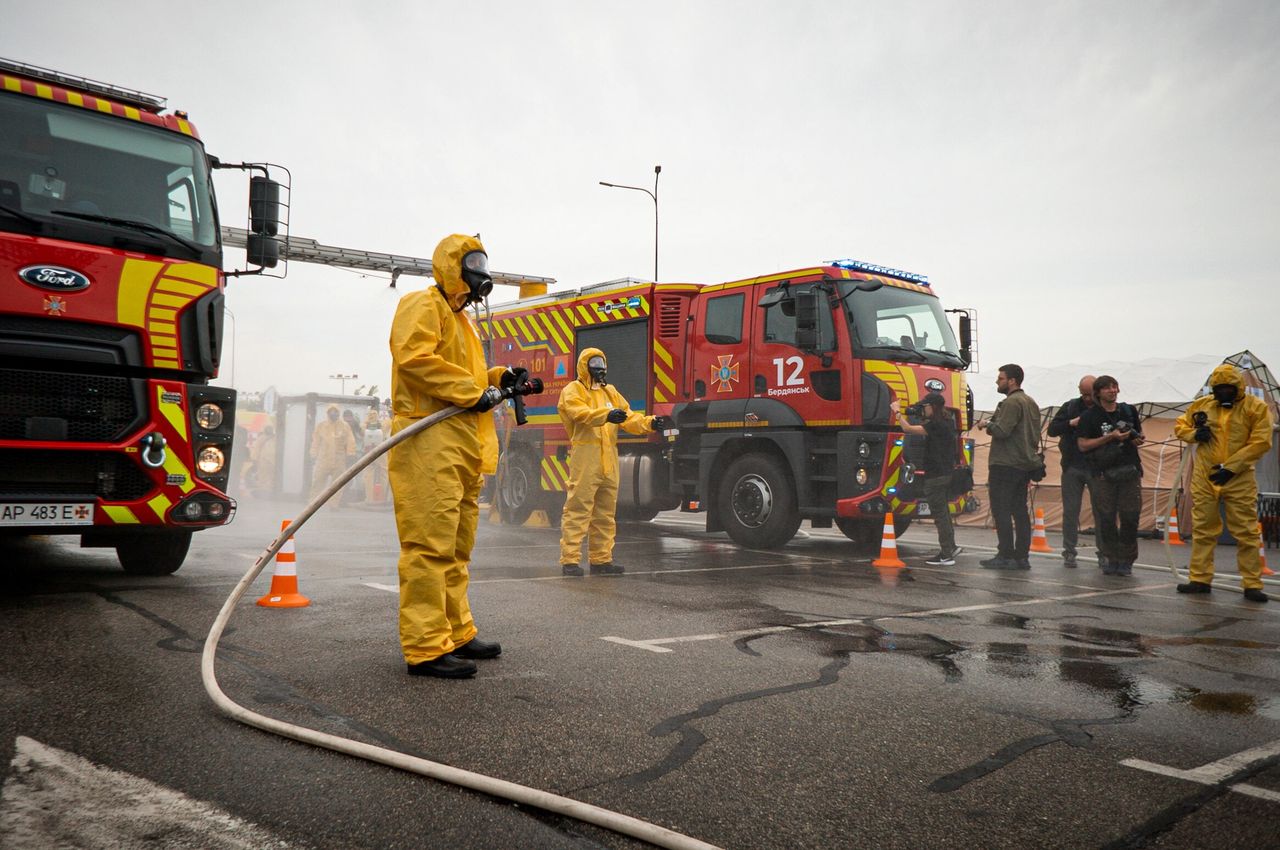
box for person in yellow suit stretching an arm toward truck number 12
[556,348,667,576]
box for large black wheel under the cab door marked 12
[717,454,800,549]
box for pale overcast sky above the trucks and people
[0,0,1280,405]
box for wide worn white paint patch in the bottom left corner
[0,735,289,850]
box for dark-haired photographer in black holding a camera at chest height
[1076,375,1146,576]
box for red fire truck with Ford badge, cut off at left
[0,60,287,575]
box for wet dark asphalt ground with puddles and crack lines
[0,501,1280,849]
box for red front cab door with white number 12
[748,283,850,426]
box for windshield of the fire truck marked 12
[837,280,965,366]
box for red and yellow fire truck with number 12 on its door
[485,260,973,548]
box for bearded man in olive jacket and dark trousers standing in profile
[978,364,1042,570]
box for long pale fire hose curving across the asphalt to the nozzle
[200,407,719,850]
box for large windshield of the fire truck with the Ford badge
[0,88,218,262]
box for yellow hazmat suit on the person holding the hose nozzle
[387,234,506,664]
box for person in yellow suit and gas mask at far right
[1174,364,1272,602]
